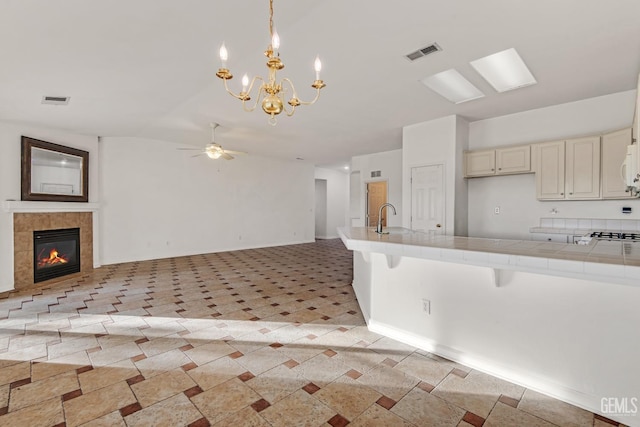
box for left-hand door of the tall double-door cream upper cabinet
[536,141,565,200]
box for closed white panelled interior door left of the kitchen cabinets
[411,165,444,234]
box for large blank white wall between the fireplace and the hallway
[101,138,315,264]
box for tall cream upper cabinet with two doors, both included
[536,136,600,200]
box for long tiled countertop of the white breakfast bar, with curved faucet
[338,227,640,286]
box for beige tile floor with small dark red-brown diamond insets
[0,240,617,427]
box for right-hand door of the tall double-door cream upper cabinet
[565,136,600,199]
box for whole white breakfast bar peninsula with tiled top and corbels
[338,227,640,425]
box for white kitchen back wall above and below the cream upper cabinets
[468,90,640,239]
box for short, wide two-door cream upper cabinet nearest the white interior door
[465,145,531,178]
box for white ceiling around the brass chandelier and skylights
[0,0,640,165]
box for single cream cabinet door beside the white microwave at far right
[602,128,631,199]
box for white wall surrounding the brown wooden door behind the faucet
[349,150,403,231]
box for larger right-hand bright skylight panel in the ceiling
[471,48,537,92]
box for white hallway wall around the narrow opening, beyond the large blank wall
[314,168,349,239]
